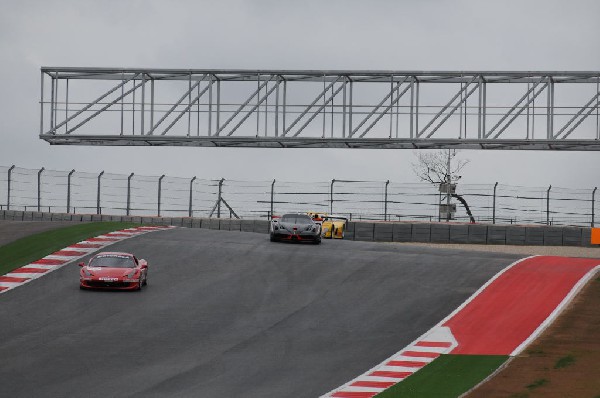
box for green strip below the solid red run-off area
[376,355,508,398]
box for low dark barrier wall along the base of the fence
[0,210,597,247]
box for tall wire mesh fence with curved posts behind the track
[0,166,598,227]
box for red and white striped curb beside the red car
[0,226,175,294]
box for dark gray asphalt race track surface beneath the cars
[0,228,520,398]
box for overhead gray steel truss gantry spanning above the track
[40,67,600,151]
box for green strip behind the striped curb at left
[0,221,140,275]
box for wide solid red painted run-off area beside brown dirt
[444,256,599,355]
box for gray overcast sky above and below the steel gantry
[0,0,600,188]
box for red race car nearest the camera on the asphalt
[79,252,148,290]
